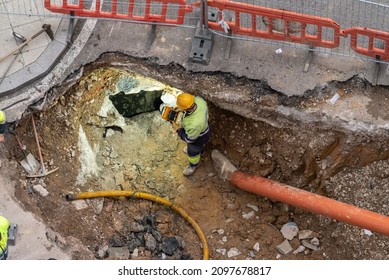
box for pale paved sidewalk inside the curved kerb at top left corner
[0,1,69,96]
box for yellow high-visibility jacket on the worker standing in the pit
[180,96,208,143]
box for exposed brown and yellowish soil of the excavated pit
[4,54,389,259]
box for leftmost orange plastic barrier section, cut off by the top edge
[45,0,193,24]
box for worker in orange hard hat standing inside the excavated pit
[177,93,211,176]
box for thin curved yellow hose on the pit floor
[66,190,209,260]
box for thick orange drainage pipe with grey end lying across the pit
[211,150,389,236]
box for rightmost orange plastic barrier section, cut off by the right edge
[343,27,389,60]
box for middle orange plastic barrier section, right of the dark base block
[194,0,342,48]
